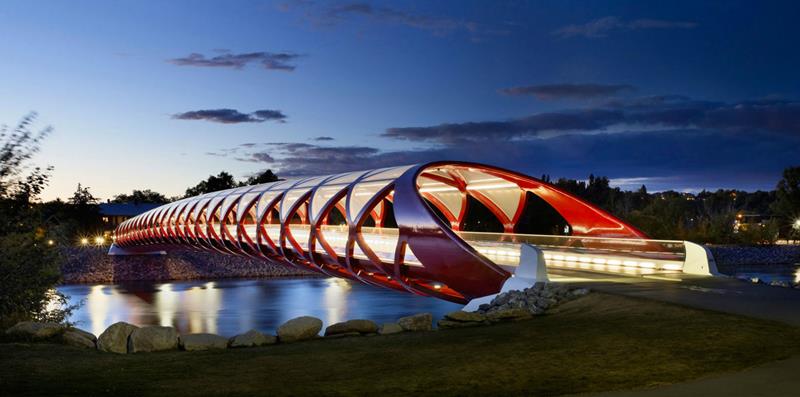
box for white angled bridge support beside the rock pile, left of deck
[461,244,550,312]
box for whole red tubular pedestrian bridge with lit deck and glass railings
[109,162,714,302]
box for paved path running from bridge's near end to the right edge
[548,268,800,324]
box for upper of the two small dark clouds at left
[168,49,300,72]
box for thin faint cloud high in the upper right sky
[553,16,697,39]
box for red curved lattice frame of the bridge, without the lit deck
[115,162,647,302]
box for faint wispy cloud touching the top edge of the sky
[279,1,500,40]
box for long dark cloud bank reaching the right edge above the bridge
[381,96,800,144]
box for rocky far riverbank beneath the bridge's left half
[61,247,319,284]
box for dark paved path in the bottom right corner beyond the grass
[580,357,800,397]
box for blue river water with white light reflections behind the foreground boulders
[59,278,461,336]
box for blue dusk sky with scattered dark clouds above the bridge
[0,0,800,200]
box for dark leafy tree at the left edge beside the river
[0,113,70,328]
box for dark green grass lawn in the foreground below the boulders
[0,293,800,396]
